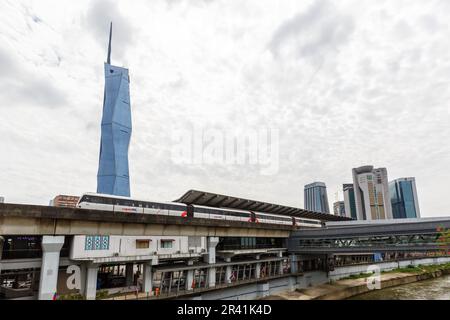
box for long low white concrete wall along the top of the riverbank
[329,257,450,280]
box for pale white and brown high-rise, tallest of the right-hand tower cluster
[352,166,393,220]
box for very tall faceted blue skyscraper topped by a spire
[97,23,131,197]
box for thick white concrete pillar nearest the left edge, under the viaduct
[38,236,64,300]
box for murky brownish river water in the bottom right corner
[349,275,450,300]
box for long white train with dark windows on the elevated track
[77,193,322,227]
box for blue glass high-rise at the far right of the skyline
[389,178,420,219]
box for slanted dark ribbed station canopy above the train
[174,190,352,221]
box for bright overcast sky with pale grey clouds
[0,0,450,217]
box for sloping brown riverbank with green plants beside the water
[265,263,450,300]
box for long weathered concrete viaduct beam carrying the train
[0,204,297,238]
